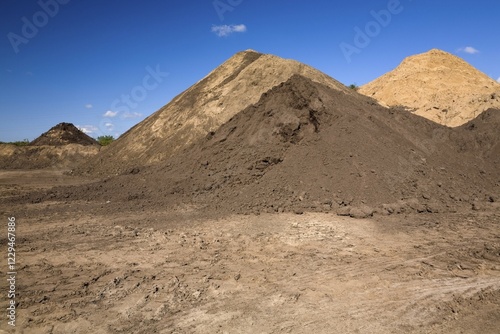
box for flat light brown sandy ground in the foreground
[0,171,500,333]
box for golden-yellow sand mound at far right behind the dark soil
[359,49,500,127]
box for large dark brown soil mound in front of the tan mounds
[13,75,500,217]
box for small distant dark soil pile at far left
[30,123,99,146]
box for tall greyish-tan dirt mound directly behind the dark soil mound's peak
[75,50,352,175]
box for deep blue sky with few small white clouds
[0,0,500,141]
